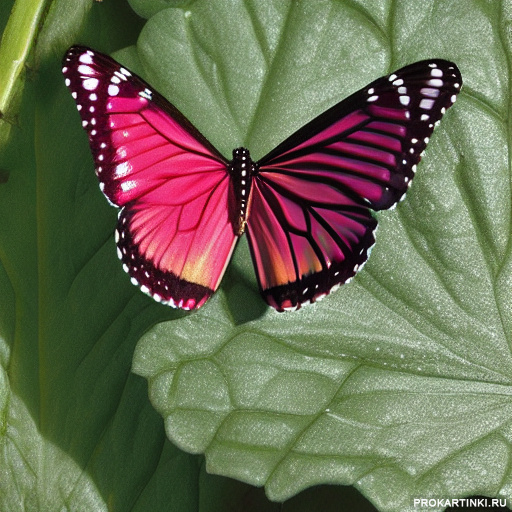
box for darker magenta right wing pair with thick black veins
[247,60,462,311]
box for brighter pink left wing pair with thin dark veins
[63,46,237,309]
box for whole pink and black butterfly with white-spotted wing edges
[62,46,462,311]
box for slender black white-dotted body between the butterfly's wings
[228,148,258,236]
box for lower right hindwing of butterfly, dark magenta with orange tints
[247,179,377,311]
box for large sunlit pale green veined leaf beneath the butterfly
[130,1,512,510]
